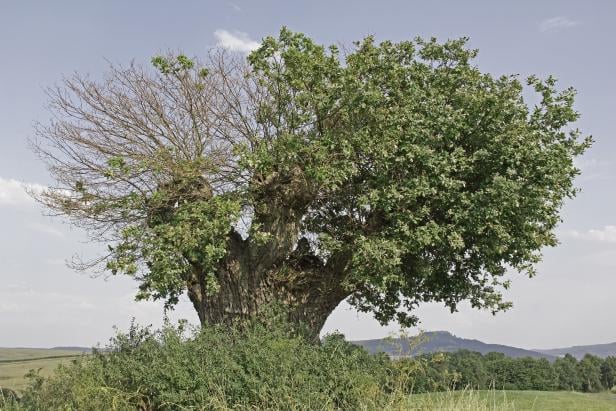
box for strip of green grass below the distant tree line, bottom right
[410,391,616,411]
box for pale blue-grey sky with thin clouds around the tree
[0,0,616,348]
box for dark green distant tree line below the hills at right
[400,350,616,392]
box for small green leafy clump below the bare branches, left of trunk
[107,193,239,305]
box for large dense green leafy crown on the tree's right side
[247,29,591,324]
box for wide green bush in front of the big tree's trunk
[8,314,410,410]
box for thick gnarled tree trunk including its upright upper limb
[188,168,350,340]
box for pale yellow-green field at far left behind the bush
[0,348,87,390]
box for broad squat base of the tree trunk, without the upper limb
[188,232,349,340]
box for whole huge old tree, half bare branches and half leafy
[34,29,591,342]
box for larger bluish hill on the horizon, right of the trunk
[353,331,556,360]
